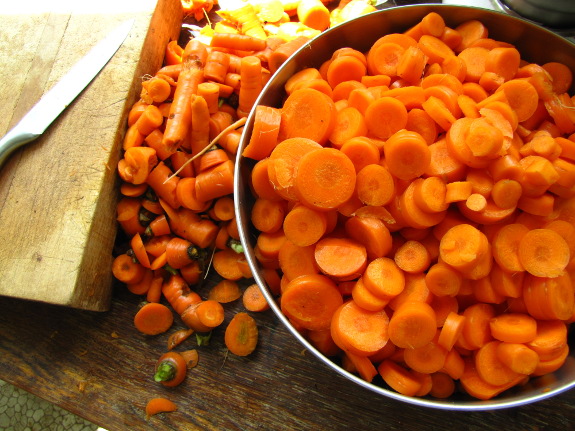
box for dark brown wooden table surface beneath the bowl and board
[0,280,575,431]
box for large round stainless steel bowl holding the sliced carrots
[234,5,575,411]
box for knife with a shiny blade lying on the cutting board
[0,19,134,168]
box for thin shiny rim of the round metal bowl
[234,4,575,411]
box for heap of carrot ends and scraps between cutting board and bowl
[112,0,382,418]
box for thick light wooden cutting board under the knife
[0,0,182,311]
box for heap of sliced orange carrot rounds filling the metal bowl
[243,13,575,400]
